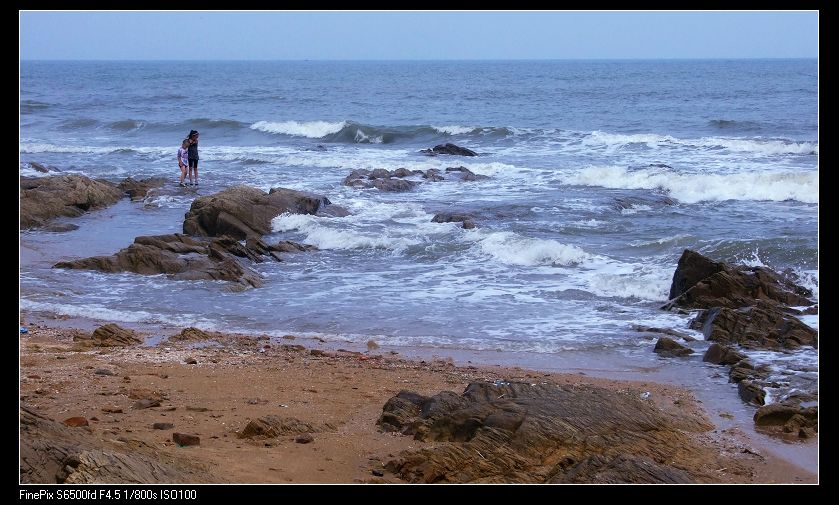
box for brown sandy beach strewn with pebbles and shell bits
[20,314,818,483]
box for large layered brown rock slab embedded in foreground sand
[378,381,715,483]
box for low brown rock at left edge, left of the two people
[20,174,122,228]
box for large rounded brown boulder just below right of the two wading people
[183,186,342,240]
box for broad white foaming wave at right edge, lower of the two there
[562,166,819,203]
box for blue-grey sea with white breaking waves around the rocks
[19,59,819,466]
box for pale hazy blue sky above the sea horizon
[19,11,819,60]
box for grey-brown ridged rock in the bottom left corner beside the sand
[20,405,210,484]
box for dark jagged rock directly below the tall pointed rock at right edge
[691,304,818,349]
